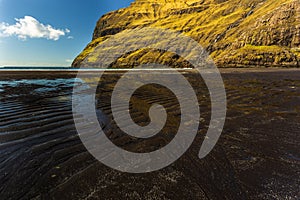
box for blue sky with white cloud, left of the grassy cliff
[0,0,133,66]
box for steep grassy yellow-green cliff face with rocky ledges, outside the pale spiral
[72,0,300,67]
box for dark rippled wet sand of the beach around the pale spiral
[0,69,300,199]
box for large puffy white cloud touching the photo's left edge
[0,16,71,41]
